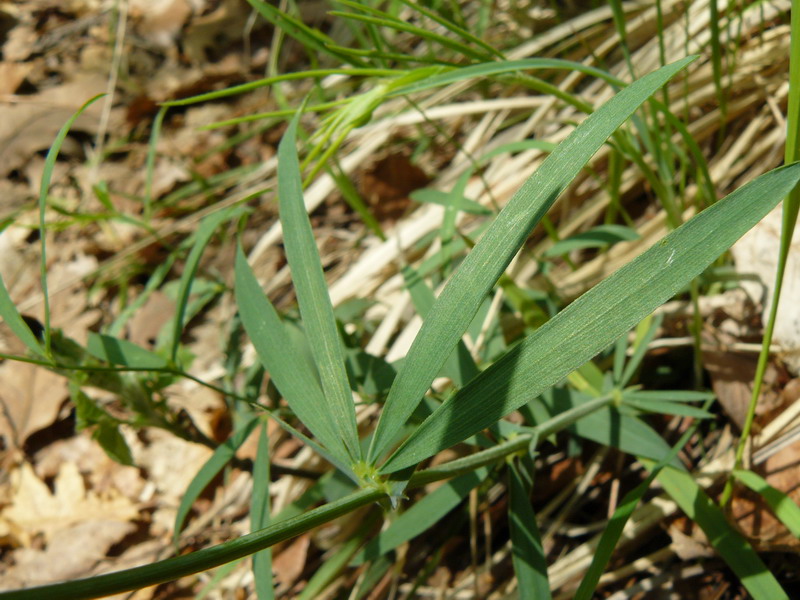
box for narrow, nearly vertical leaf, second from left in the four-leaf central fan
[278,112,361,461]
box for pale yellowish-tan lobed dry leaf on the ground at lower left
[0,462,139,547]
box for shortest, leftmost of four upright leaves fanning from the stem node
[234,247,349,462]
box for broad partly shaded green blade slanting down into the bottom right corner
[642,460,789,600]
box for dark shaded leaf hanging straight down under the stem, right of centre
[508,463,551,600]
